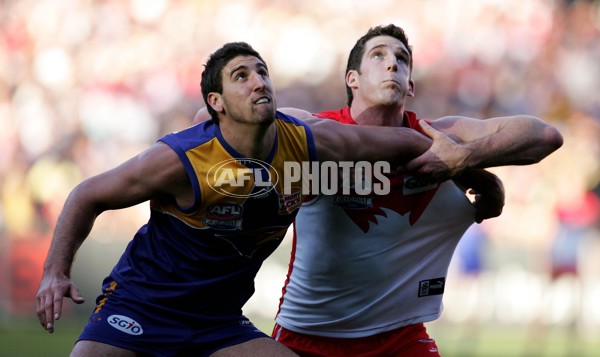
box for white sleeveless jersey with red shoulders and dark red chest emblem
[276,108,474,338]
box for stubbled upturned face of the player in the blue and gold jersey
[213,56,276,123]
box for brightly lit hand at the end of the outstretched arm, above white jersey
[403,120,469,182]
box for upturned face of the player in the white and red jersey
[347,36,413,105]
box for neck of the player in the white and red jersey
[350,99,404,126]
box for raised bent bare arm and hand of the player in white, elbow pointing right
[407,115,563,177]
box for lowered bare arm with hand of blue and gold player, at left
[37,143,191,332]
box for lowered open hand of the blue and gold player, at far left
[37,273,85,333]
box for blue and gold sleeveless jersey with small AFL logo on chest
[111,112,316,319]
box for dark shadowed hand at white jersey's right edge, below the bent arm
[454,169,504,223]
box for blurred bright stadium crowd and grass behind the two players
[0,0,600,356]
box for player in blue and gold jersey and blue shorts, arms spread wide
[37,43,478,356]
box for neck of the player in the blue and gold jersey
[219,120,277,160]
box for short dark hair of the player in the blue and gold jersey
[200,42,266,121]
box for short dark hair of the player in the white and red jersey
[345,24,412,105]
